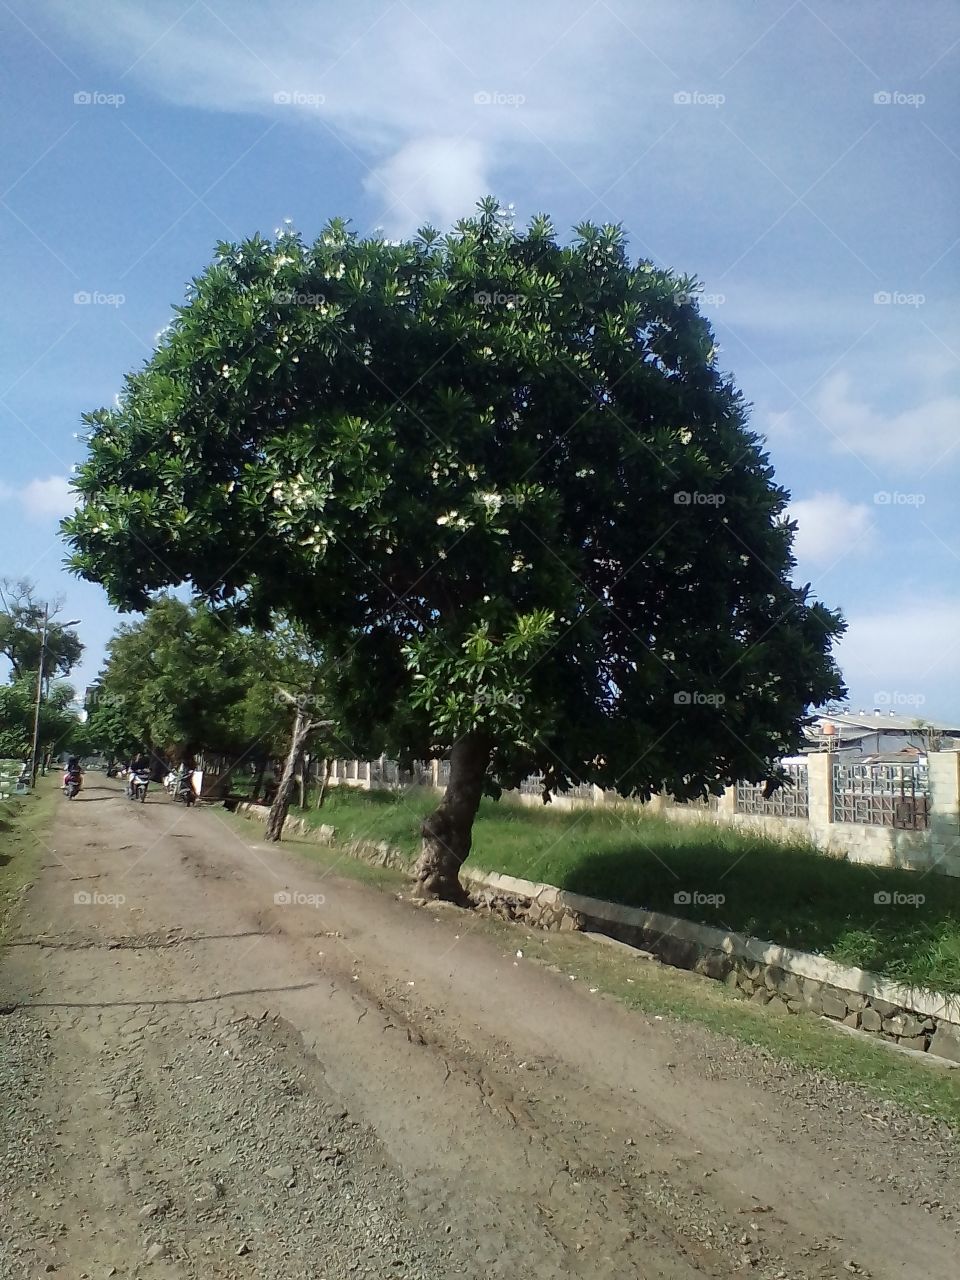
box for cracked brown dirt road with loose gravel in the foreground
[0,776,960,1280]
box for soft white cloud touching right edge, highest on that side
[814,372,960,471]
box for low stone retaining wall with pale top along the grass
[236,803,960,1062]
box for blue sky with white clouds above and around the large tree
[0,0,960,722]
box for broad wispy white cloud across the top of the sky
[45,0,773,232]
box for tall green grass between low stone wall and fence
[300,787,960,993]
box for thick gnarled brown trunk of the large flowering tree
[413,733,490,905]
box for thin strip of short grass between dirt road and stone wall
[225,806,960,1128]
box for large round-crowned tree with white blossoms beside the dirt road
[65,201,842,896]
